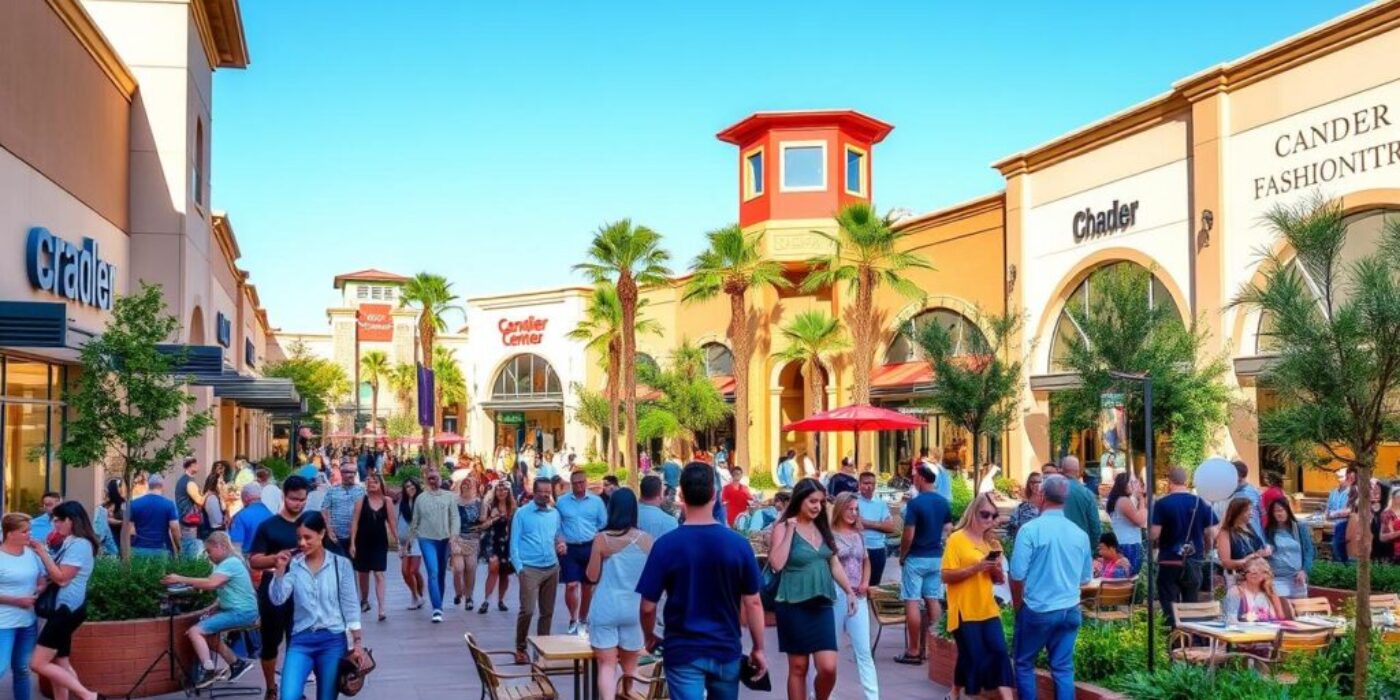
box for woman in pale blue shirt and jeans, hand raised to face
[267,511,365,700]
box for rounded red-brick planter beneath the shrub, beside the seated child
[39,610,206,697]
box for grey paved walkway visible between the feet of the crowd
[112,553,945,700]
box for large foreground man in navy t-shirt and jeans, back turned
[637,463,767,700]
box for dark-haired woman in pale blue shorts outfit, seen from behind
[587,489,651,697]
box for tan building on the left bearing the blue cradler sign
[0,0,287,512]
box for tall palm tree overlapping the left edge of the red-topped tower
[682,225,792,466]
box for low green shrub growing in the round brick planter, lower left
[87,557,214,622]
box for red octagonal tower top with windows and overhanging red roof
[715,109,895,228]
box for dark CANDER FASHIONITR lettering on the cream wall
[1253,104,1400,202]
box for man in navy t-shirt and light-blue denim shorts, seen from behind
[895,465,953,665]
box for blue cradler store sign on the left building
[25,227,116,311]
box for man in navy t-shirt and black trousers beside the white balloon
[1152,466,1219,624]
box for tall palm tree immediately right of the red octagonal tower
[802,203,934,403]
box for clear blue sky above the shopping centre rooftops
[213,0,1359,330]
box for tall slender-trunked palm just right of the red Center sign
[574,218,671,489]
